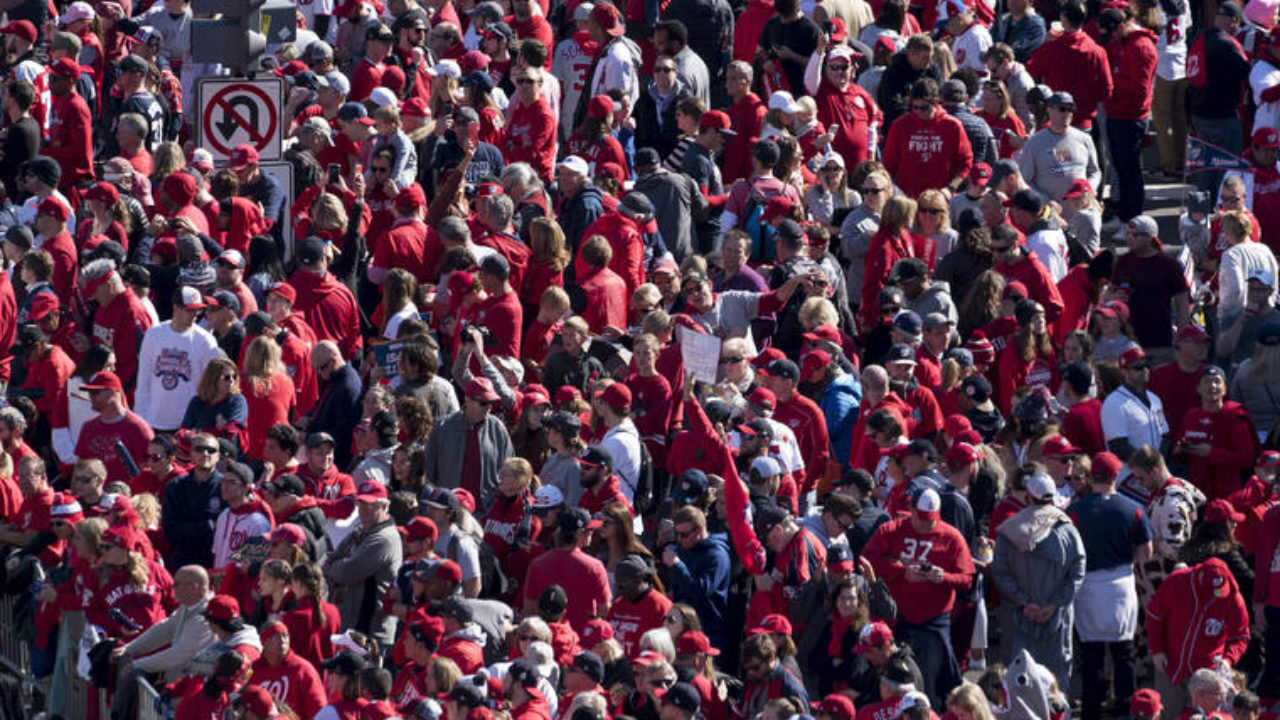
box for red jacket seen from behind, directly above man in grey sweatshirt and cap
[1027,31,1112,128]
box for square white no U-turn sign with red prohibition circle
[198,78,284,161]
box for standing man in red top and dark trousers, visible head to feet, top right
[1098,8,1156,222]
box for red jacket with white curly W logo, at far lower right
[1147,556,1244,683]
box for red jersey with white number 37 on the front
[863,515,975,624]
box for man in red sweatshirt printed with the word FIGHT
[884,78,973,197]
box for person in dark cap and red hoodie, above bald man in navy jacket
[291,235,365,357]
